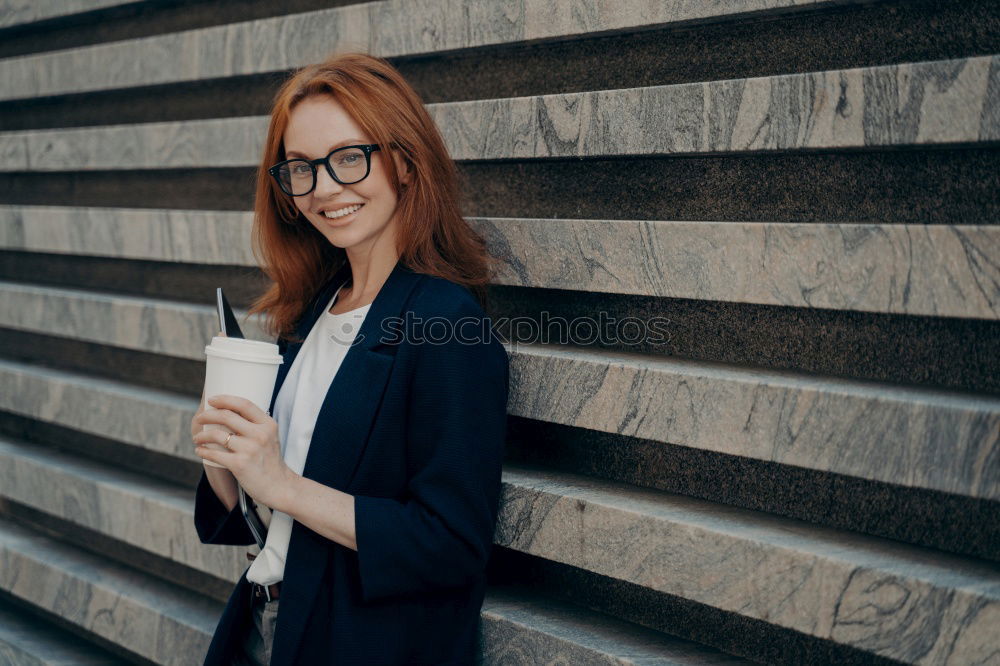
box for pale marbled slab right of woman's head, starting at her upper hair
[431,56,1000,160]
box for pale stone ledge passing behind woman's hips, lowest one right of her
[0,437,746,664]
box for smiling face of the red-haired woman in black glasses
[284,95,411,256]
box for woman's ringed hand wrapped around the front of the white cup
[192,395,296,507]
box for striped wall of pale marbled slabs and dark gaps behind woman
[0,0,1000,666]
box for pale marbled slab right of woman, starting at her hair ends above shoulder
[470,218,1000,319]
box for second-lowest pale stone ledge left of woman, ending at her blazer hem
[0,519,222,666]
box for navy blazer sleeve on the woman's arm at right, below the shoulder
[354,298,509,601]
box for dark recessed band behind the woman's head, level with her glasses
[0,146,1000,225]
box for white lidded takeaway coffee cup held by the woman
[202,335,282,469]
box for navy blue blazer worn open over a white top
[194,262,509,666]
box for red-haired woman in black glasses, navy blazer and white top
[191,54,508,665]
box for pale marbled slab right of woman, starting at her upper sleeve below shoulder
[507,343,1000,500]
